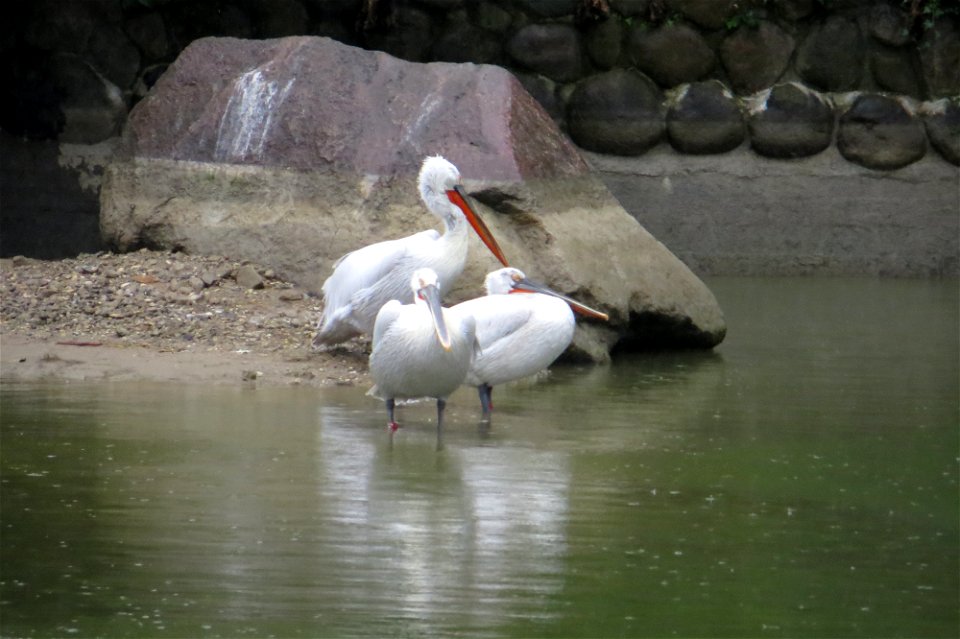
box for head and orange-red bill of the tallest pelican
[417,155,509,266]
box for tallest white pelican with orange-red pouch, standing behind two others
[313,155,507,346]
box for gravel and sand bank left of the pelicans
[0,249,368,385]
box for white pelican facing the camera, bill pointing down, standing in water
[370,268,476,442]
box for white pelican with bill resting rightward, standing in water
[451,267,608,420]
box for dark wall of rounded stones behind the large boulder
[0,0,960,272]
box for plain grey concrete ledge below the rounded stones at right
[584,145,960,277]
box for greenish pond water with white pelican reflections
[0,278,960,637]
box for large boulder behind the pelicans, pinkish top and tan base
[101,37,726,359]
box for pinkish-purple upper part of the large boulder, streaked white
[125,37,588,180]
